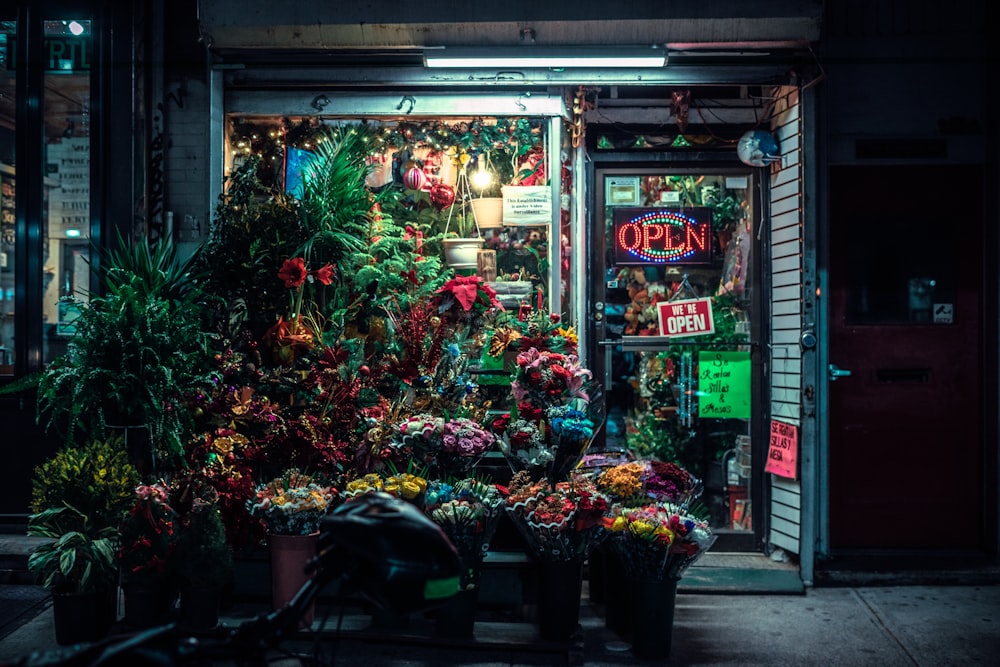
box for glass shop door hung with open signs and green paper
[593,169,759,544]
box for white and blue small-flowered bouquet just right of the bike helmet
[424,477,504,590]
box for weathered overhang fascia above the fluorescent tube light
[198,0,823,57]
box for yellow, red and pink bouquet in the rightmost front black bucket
[605,502,716,581]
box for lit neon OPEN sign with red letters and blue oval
[614,207,712,264]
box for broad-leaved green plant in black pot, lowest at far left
[28,505,118,593]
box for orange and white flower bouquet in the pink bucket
[247,468,337,535]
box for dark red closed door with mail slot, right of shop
[829,166,984,550]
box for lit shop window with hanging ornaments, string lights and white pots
[225,115,570,314]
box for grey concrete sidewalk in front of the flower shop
[0,585,1000,667]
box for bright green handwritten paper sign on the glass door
[698,352,750,419]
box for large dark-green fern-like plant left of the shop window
[37,235,214,458]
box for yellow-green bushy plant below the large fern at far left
[31,438,139,528]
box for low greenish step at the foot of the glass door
[677,551,805,595]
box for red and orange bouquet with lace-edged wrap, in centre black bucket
[505,470,608,563]
